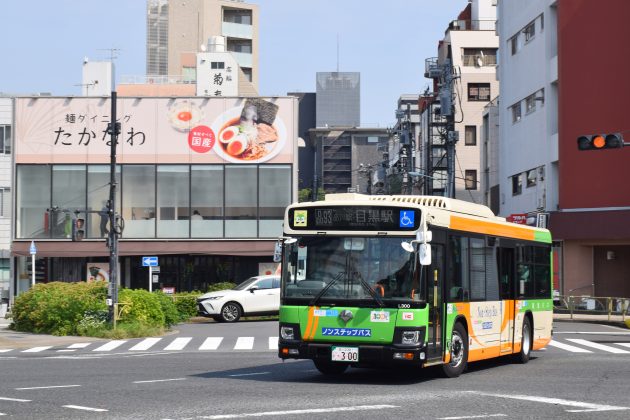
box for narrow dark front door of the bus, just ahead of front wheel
[423,244,444,364]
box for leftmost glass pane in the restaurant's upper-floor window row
[15,165,50,238]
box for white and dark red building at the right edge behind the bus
[499,0,630,297]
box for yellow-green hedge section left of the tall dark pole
[12,282,107,335]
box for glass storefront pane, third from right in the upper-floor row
[190,165,223,238]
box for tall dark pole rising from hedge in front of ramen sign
[107,91,119,322]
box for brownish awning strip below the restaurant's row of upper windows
[11,240,275,257]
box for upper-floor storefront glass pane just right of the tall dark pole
[122,165,155,238]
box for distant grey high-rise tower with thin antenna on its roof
[316,72,361,128]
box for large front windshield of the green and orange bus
[282,236,421,306]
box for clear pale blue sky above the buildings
[0,0,468,127]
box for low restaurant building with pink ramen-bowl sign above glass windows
[12,97,297,293]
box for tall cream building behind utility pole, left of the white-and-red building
[419,0,499,203]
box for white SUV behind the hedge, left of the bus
[197,275,280,322]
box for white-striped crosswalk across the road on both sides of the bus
[0,336,630,358]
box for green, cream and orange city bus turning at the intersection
[274,193,553,377]
